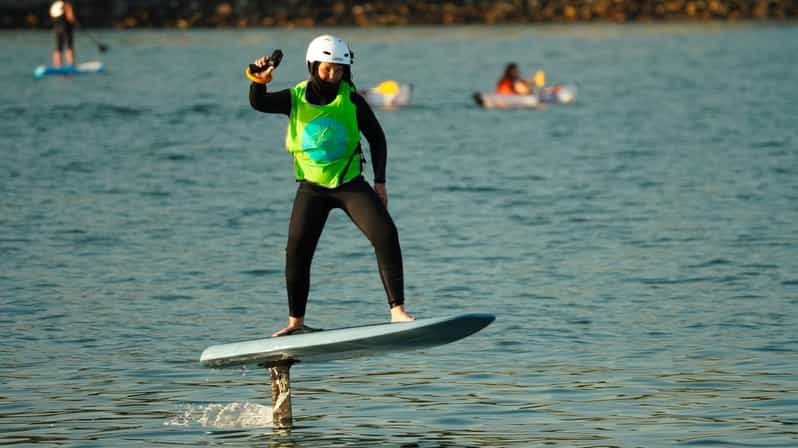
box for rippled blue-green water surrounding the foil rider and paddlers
[0,24,798,447]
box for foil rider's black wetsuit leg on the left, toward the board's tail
[285,182,334,317]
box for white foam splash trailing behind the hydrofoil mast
[164,403,272,429]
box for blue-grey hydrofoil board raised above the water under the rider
[200,313,496,368]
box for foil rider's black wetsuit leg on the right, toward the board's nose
[336,177,405,308]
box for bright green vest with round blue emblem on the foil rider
[285,81,361,188]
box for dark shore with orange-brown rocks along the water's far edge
[0,0,798,29]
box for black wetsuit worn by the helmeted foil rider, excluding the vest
[249,79,404,317]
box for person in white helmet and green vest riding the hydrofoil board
[246,35,415,336]
